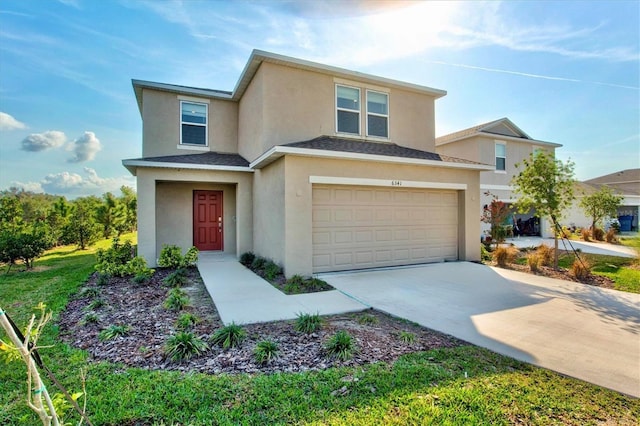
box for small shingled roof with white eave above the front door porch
[122,152,251,175]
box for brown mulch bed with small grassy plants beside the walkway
[59,269,466,373]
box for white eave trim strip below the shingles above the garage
[249,145,494,171]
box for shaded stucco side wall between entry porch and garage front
[253,159,286,264]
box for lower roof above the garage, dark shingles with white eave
[251,136,493,170]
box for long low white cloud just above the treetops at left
[11,167,135,197]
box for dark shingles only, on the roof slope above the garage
[282,136,482,164]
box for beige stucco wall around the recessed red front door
[137,168,253,265]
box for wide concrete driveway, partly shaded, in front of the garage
[321,262,640,397]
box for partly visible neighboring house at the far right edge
[565,169,640,231]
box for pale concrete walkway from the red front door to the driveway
[198,252,366,324]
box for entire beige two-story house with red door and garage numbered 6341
[123,51,493,276]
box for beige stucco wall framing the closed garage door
[274,156,480,276]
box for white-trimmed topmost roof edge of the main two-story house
[131,49,447,113]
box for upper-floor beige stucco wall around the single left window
[142,89,238,157]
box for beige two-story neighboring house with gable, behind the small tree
[436,118,562,237]
